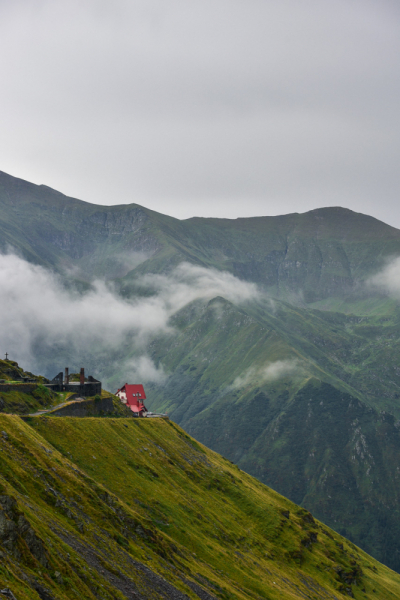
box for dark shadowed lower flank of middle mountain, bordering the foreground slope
[186,380,400,570]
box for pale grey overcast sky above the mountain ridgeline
[0,0,400,227]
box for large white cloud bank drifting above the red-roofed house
[0,254,258,381]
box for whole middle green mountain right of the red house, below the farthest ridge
[108,298,400,570]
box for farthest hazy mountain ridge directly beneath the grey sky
[0,172,400,302]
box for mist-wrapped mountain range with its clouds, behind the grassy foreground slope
[0,173,400,570]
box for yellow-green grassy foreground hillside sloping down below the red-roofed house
[0,416,400,600]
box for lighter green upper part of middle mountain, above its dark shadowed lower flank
[141,298,400,422]
